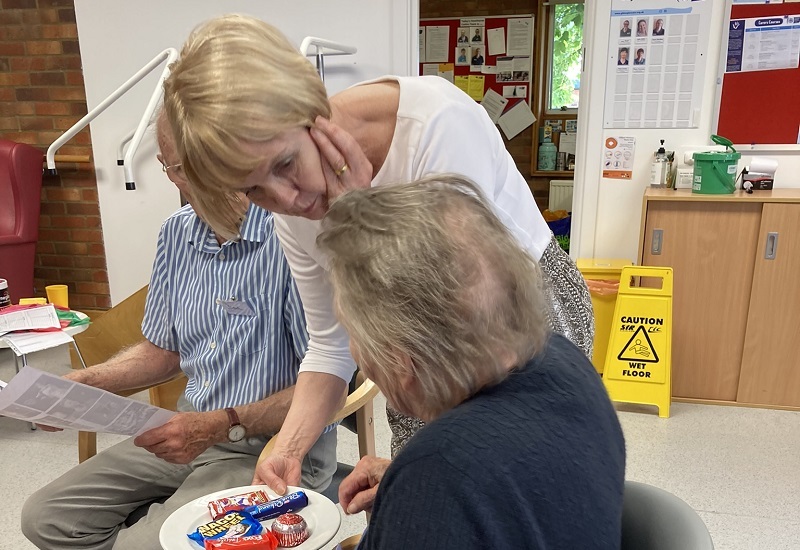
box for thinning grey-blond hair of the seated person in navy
[317,174,549,418]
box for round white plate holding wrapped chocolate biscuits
[158,485,342,550]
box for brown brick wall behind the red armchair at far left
[0,0,111,309]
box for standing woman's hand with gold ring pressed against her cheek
[310,116,372,204]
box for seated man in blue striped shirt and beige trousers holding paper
[22,113,336,549]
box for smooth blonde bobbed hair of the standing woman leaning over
[164,15,330,238]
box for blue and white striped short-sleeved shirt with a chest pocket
[142,205,308,411]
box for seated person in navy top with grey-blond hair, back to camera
[318,175,625,550]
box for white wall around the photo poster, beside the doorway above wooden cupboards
[571,0,800,263]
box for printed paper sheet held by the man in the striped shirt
[0,367,175,436]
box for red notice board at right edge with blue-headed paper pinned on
[716,2,800,145]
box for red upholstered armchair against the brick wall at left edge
[0,139,43,303]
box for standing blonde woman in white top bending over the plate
[164,11,594,492]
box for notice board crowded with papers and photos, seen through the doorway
[419,15,533,112]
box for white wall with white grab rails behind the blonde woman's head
[75,0,419,304]
